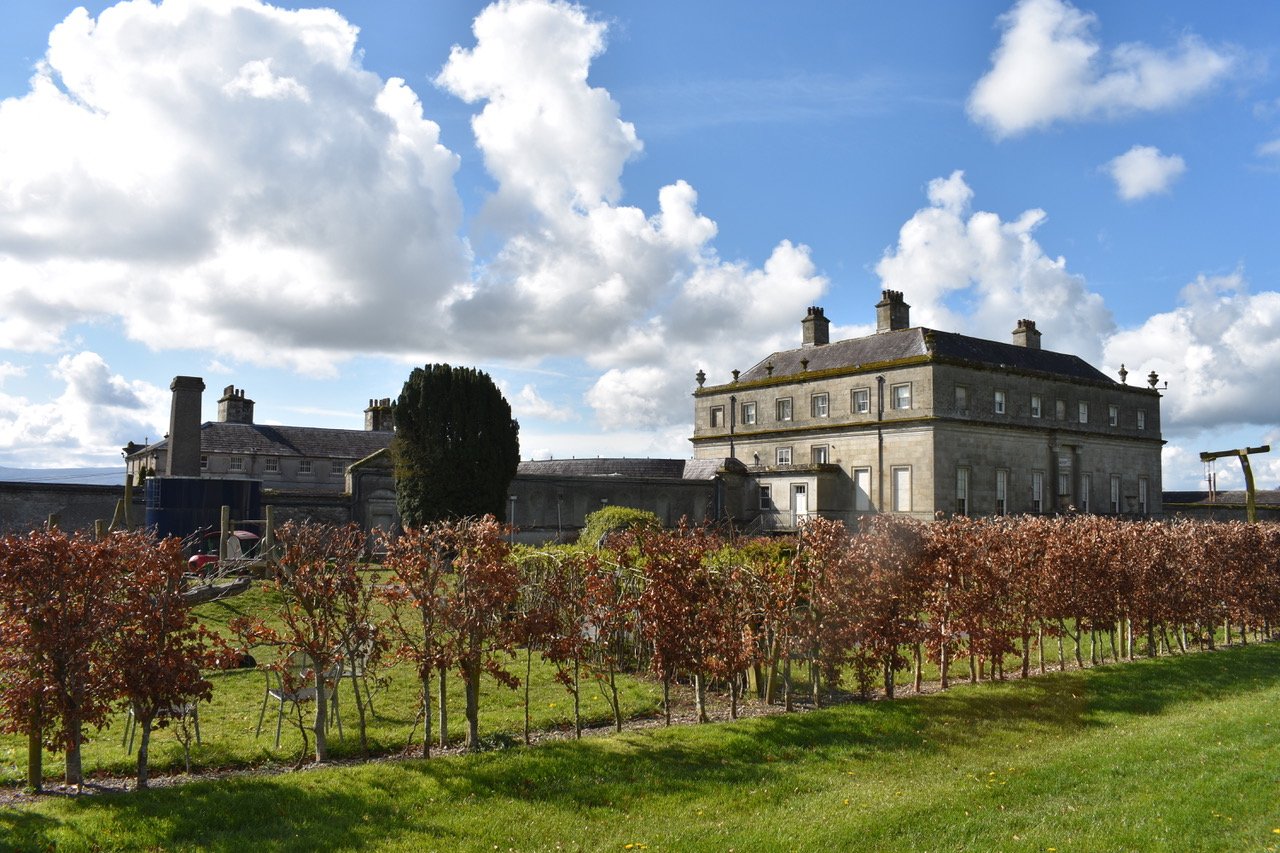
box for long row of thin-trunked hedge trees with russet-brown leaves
[0,516,1280,784]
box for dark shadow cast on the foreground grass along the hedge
[0,644,1280,849]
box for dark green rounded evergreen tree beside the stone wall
[392,364,520,526]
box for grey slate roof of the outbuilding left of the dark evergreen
[133,421,394,460]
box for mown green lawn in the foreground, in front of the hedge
[0,644,1280,852]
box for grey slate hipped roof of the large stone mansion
[739,327,1115,383]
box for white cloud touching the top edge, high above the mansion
[969,0,1238,137]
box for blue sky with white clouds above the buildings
[0,0,1280,488]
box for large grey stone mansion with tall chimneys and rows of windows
[692,291,1164,529]
